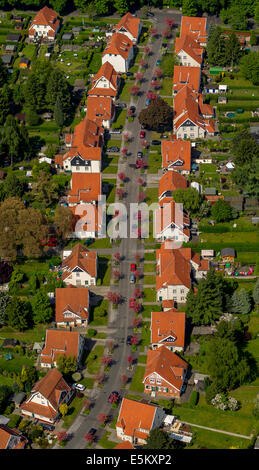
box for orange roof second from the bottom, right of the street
[143,346,188,391]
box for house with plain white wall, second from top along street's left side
[102,33,134,73]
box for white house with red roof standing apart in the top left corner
[29,6,60,41]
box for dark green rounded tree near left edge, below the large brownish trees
[6,297,30,331]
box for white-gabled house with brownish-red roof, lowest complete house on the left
[20,369,75,424]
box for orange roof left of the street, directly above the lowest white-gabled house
[40,330,82,364]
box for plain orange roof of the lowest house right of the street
[116,398,157,439]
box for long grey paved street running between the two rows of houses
[56,11,180,449]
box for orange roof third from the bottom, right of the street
[150,308,185,348]
